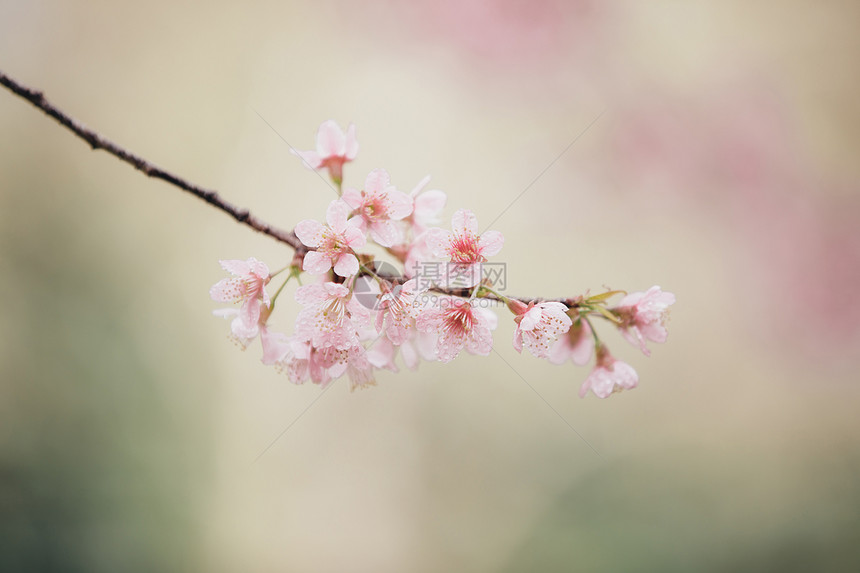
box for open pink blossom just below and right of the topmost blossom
[343,169,412,247]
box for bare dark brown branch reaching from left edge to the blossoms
[0,71,308,253]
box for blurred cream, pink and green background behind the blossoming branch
[0,0,860,572]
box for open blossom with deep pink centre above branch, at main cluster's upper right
[428,209,505,287]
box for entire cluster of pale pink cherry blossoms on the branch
[210,121,675,398]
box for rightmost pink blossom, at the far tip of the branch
[612,286,675,356]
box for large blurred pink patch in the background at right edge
[608,79,860,358]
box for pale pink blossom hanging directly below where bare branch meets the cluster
[296,282,370,350]
